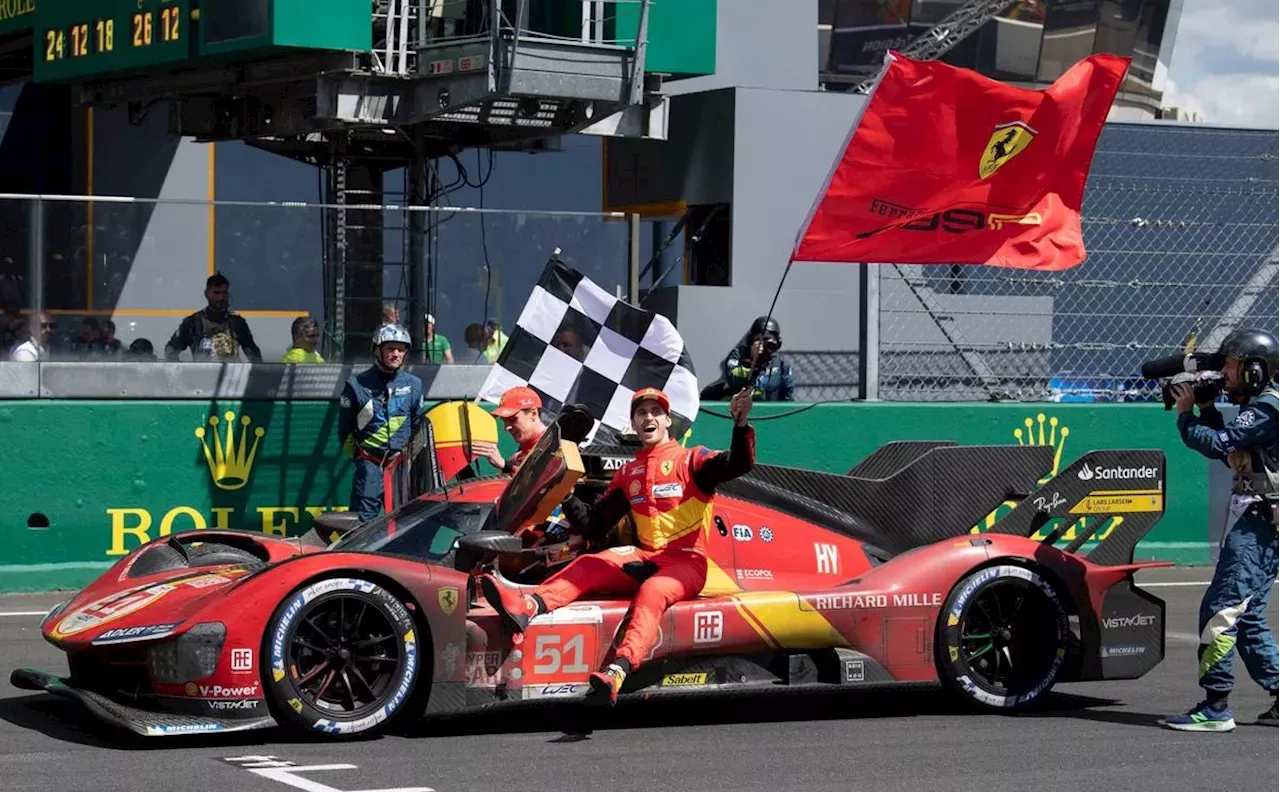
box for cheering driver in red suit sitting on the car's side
[480,388,755,706]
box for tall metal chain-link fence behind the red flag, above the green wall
[878,124,1280,402]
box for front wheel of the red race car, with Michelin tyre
[261,577,426,740]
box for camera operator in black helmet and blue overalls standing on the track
[1162,329,1280,732]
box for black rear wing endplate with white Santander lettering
[988,449,1166,566]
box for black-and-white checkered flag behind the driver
[480,257,699,440]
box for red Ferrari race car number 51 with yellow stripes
[12,403,1170,736]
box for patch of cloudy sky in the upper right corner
[1164,0,1280,127]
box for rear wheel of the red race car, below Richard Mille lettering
[936,563,1071,713]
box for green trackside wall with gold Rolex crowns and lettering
[0,400,1210,591]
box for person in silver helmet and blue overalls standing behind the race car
[338,325,426,522]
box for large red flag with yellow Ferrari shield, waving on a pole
[791,52,1129,270]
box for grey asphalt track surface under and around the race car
[0,568,1280,792]
